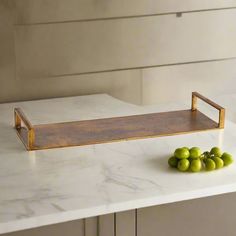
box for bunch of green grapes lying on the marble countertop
[168,147,233,172]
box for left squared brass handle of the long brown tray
[14,108,35,150]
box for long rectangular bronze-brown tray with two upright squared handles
[14,92,225,150]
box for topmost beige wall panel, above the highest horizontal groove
[16,0,236,24]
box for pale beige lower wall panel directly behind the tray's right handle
[142,60,236,105]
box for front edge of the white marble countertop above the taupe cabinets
[0,183,236,234]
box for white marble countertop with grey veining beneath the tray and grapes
[0,95,236,233]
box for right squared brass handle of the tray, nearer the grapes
[192,92,225,129]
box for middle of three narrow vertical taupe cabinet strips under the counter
[98,214,115,236]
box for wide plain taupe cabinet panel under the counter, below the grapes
[138,193,236,236]
